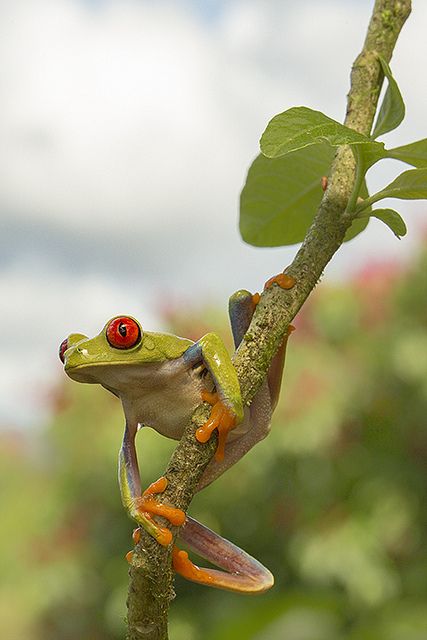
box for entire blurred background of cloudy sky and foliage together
[0,0,427,640]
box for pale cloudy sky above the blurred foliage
[0,0,427,426]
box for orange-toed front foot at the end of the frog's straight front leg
[131,476,185,547]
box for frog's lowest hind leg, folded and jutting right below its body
[172,516,274,594]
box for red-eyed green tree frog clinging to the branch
[59,274,295,593]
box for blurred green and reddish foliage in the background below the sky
[0,252,427,640]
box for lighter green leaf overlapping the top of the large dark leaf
[260,107,371,158]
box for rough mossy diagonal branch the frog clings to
[127,0,411,640]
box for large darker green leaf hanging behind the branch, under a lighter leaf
[240,143,369,247]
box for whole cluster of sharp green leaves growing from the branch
[240,56,427,247]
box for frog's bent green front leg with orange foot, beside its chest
[183,333,243,461]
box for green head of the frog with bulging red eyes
[59,316,145,384]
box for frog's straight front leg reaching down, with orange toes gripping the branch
[119,424,185,546]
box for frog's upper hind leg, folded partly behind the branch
[198,289,289,491]
